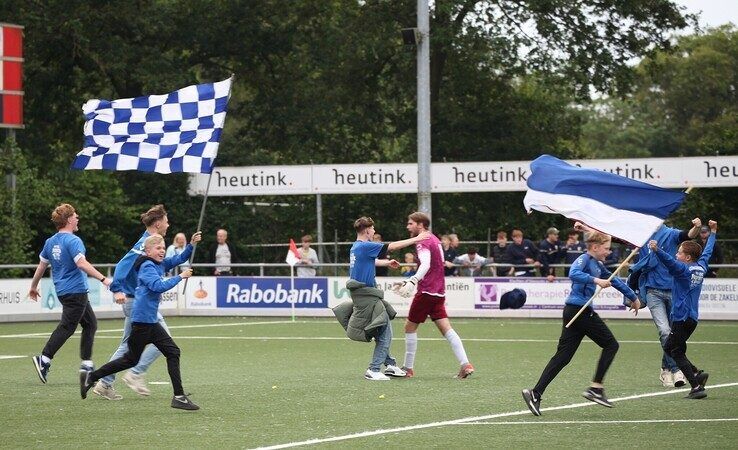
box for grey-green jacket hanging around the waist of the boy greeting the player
[333,280,397,342]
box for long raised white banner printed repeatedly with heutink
[189,156,738,196]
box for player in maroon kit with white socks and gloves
[396,212,474,379]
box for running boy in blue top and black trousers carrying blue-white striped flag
[523,232,641,416]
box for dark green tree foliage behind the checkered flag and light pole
[0,0,720,268]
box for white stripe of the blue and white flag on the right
[523,189,663,246]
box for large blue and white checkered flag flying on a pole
[72,78,232,173]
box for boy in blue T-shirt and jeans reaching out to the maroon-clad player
[349,217,430,381]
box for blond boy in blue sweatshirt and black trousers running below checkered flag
[80,231,202,411]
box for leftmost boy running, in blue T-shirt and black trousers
[28,203,111,383]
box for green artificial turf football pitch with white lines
[0,317,738,448]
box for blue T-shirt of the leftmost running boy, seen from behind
[39,233,89,297]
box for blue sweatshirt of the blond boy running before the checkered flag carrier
[131,244,192,323]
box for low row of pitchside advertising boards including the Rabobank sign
[0,277,738,322]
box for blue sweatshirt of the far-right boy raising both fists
[656,233,715,322]
